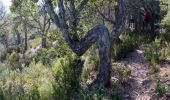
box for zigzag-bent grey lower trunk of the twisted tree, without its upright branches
[67,25,111,86]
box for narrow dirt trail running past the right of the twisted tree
[113,45,154,100]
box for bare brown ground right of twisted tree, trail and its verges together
[111,45,170,100]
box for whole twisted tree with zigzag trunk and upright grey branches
[44,0,125,86]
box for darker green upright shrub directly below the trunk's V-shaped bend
[52,55,83,99]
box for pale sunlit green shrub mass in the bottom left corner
[0,63,54,100]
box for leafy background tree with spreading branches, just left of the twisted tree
[11,0,51,48]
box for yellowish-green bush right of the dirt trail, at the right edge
[144,37,170,72]
